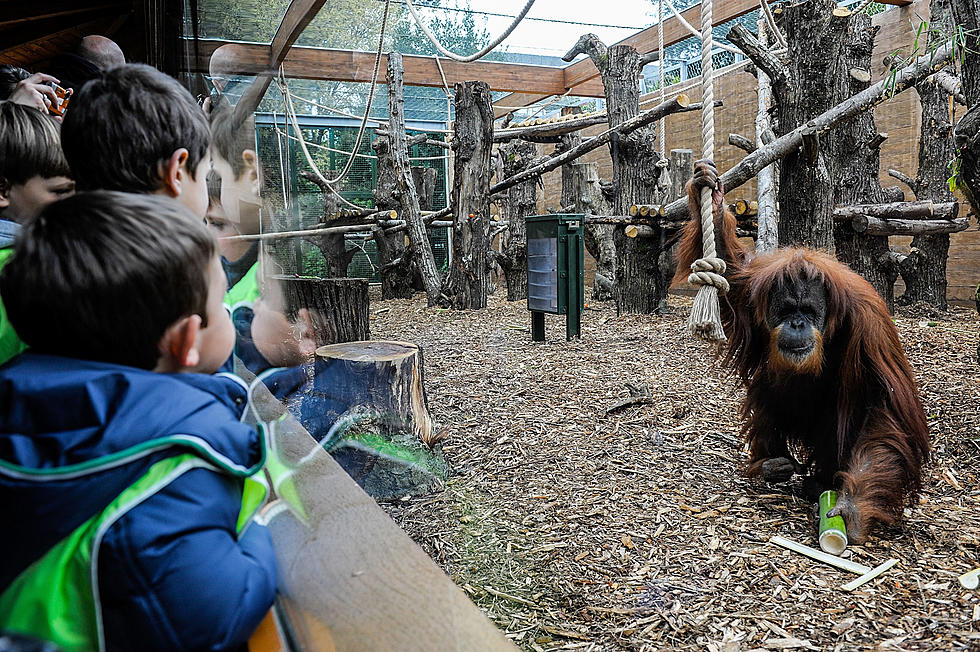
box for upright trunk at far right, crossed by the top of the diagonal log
[900,0,956,311]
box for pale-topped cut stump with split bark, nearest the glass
[314,338,436,446]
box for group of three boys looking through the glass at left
[0,59,294,650]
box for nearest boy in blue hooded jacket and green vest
[0,191,276,650]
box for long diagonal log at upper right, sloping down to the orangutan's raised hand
[667,36,953,224]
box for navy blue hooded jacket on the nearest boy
[0,352,276,650]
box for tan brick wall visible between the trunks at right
[538,0,980,302]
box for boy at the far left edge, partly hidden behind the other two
[0,102,75,364]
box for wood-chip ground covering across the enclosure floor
[371,290,980,650]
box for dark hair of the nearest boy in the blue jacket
[0,190,216,369]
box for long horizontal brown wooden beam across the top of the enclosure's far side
[202,40,603,97]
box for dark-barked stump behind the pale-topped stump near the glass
[273,276,371,344]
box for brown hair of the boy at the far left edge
[0,102,71,187]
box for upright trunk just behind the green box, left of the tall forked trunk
[561,158,616,301]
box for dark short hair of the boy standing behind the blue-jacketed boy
[61,63,210,192]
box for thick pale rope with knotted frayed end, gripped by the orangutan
[687,0,728,342]
